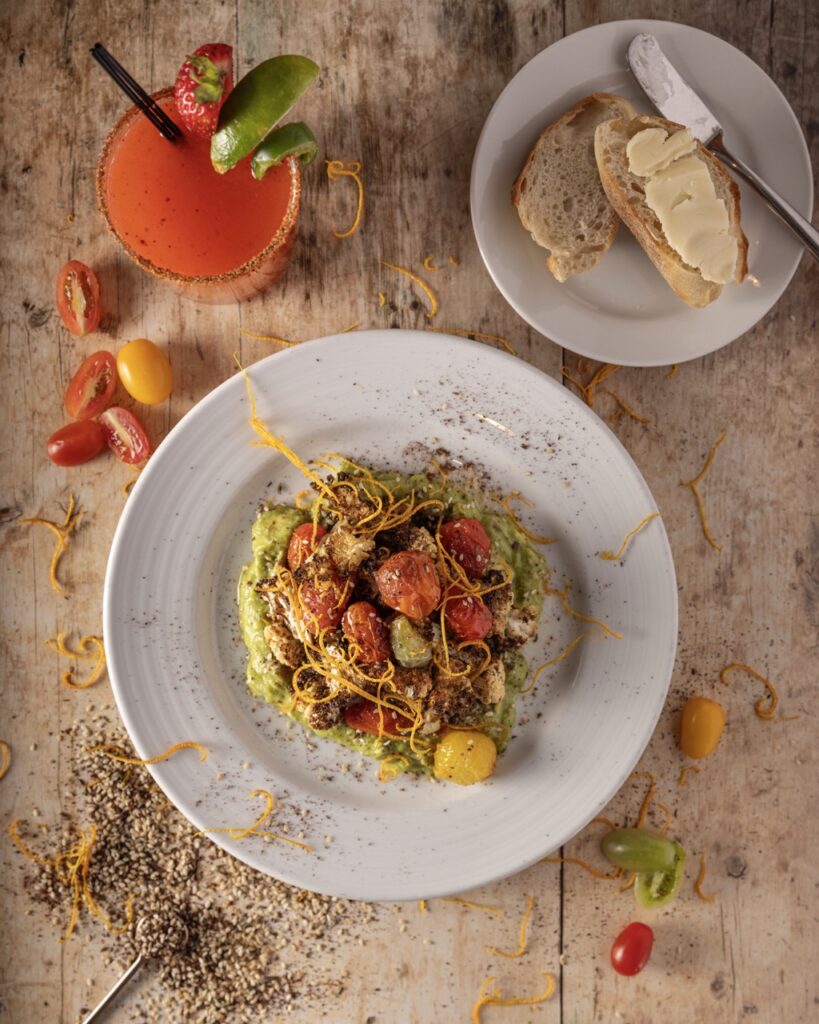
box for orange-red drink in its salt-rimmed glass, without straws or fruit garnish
[97,89,301,302]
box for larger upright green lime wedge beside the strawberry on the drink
[211,53,318,174]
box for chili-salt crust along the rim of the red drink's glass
[96,87,301,287]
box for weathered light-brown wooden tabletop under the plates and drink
[0,0,819,1024]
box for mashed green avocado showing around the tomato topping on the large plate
[239,472,547,775]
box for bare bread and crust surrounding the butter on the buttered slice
[595,116,748,307]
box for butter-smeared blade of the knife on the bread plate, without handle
[627,32,723,145]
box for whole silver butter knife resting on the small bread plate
[627,32,819,260]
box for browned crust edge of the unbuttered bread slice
[512,92,636,282]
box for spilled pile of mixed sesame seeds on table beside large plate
[13,713,377,1024]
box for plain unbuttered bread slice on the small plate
[512,92,637,282]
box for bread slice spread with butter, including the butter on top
[595,117,748,306]
